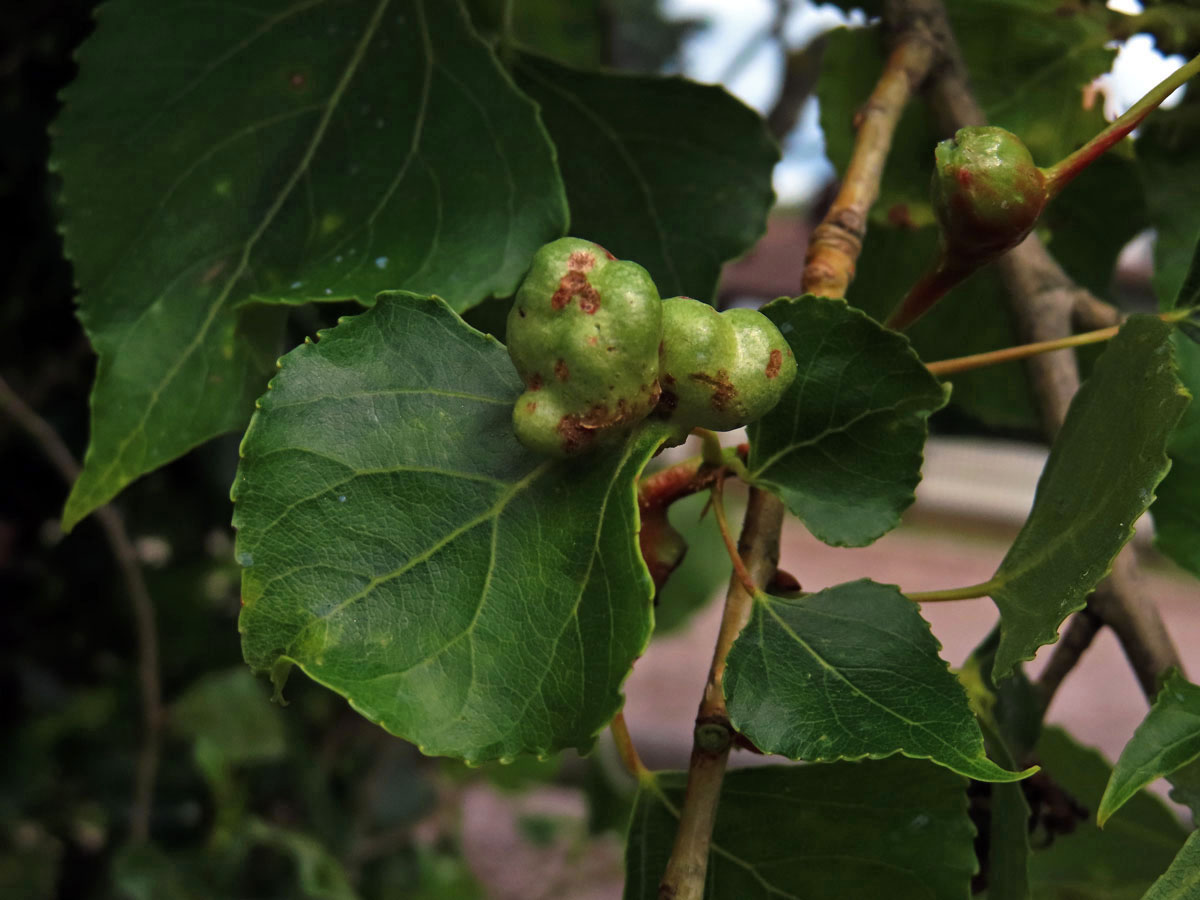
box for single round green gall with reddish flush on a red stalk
[932,126,1049,259]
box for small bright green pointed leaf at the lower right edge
[1096,670,1200,826]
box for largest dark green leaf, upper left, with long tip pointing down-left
[53,0,566,528]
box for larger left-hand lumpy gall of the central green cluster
[508,238,662,457]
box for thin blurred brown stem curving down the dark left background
[0,378,162,844]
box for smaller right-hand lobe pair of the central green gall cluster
[659,296,796,433]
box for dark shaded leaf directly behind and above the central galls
[514,54,779,300]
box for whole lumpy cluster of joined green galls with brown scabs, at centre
[508,238,796,457]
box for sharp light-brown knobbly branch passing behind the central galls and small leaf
[659,12,936,900]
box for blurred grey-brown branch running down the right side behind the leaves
[896,0,1180,697]
